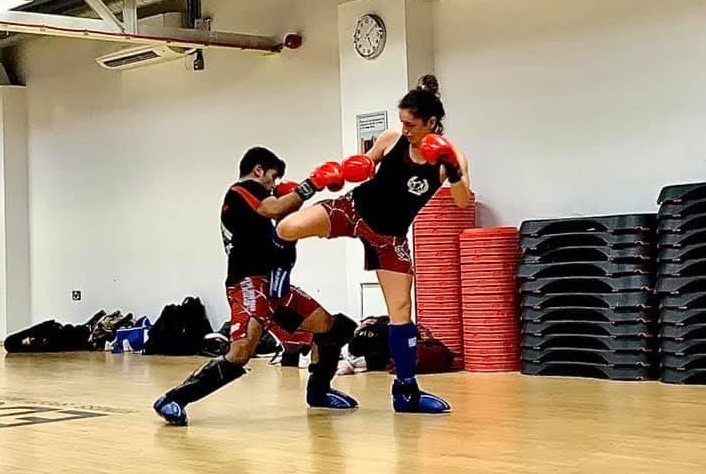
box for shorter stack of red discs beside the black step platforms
[460,227,520,372]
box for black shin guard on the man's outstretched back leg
[165,356,245,406]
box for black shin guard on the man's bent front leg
[309,314,358,392]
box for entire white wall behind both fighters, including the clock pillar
[12,0,706,330]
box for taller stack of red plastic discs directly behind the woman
[413,188,476,370]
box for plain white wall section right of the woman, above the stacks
[434,0,706,225]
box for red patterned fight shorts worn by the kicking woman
[319,193,414,275]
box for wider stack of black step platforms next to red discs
[518,214,658,380]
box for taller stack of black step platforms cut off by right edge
[657,183,706,384]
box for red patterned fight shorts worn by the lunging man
[226,276,320,342]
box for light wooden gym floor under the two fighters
[0,348,706,474]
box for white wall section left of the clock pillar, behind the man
[20,0,346,323]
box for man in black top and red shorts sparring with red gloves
[153,147,366,425]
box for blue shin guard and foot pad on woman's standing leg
[390,323,451,413]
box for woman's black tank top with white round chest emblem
[353,136,441,237]
